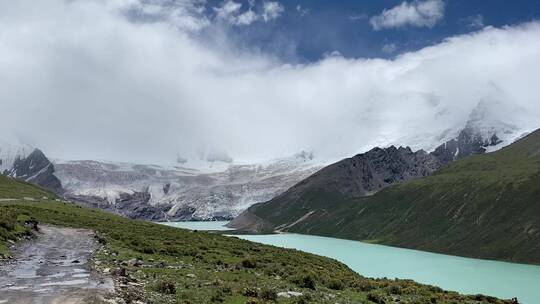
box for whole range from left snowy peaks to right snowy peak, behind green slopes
[0,101,523,224]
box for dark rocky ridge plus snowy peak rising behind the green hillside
[229,101,522,231]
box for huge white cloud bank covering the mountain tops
[0,0,540,166]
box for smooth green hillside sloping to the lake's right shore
[262,131,540,264]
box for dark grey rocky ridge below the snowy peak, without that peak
[229,146,441,230]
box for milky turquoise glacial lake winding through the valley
[161,222,540,304]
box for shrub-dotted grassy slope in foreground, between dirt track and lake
[0,179,509,304]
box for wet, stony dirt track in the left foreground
[0,226,114,304]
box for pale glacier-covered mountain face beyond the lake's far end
[54,153,320,221]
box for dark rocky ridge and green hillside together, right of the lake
[229,124,540,264]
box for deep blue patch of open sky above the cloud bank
[200,0,540,62]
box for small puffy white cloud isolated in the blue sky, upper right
[369,0,444,31]
